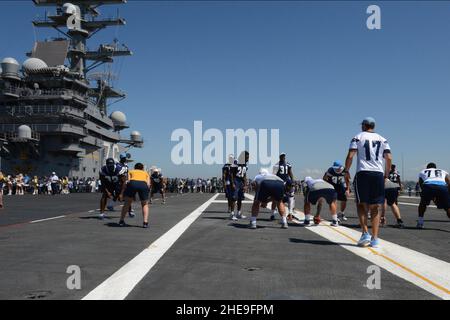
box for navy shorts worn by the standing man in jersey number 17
[355,171,385,204]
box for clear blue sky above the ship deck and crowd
[0,1,450,179]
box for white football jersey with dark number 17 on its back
[350,132,391,173]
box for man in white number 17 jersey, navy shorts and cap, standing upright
[345,117,392,248]
